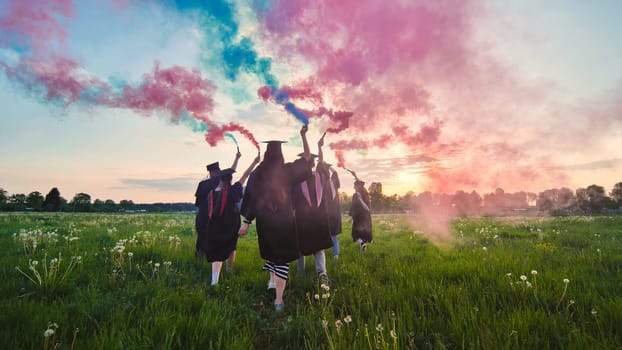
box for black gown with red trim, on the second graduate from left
[201,182,242,262]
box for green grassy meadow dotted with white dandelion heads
[0,213,622,349]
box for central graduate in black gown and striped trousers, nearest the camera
[240,125,311,311]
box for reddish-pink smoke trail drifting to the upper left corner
[0,0,259,152]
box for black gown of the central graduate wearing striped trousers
[242,159,311,264]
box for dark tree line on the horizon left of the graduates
[0,187,195,213]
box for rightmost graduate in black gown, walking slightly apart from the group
[350,172,372,250]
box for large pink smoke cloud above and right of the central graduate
[252,0,474,172]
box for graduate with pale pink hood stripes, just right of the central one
[292,136,333,285]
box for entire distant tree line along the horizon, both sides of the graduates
[0,182,622,216]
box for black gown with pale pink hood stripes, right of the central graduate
[292,168,333,255]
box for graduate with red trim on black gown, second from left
[205,155,259,285]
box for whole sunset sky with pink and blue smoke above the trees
[0,0,622,203]
